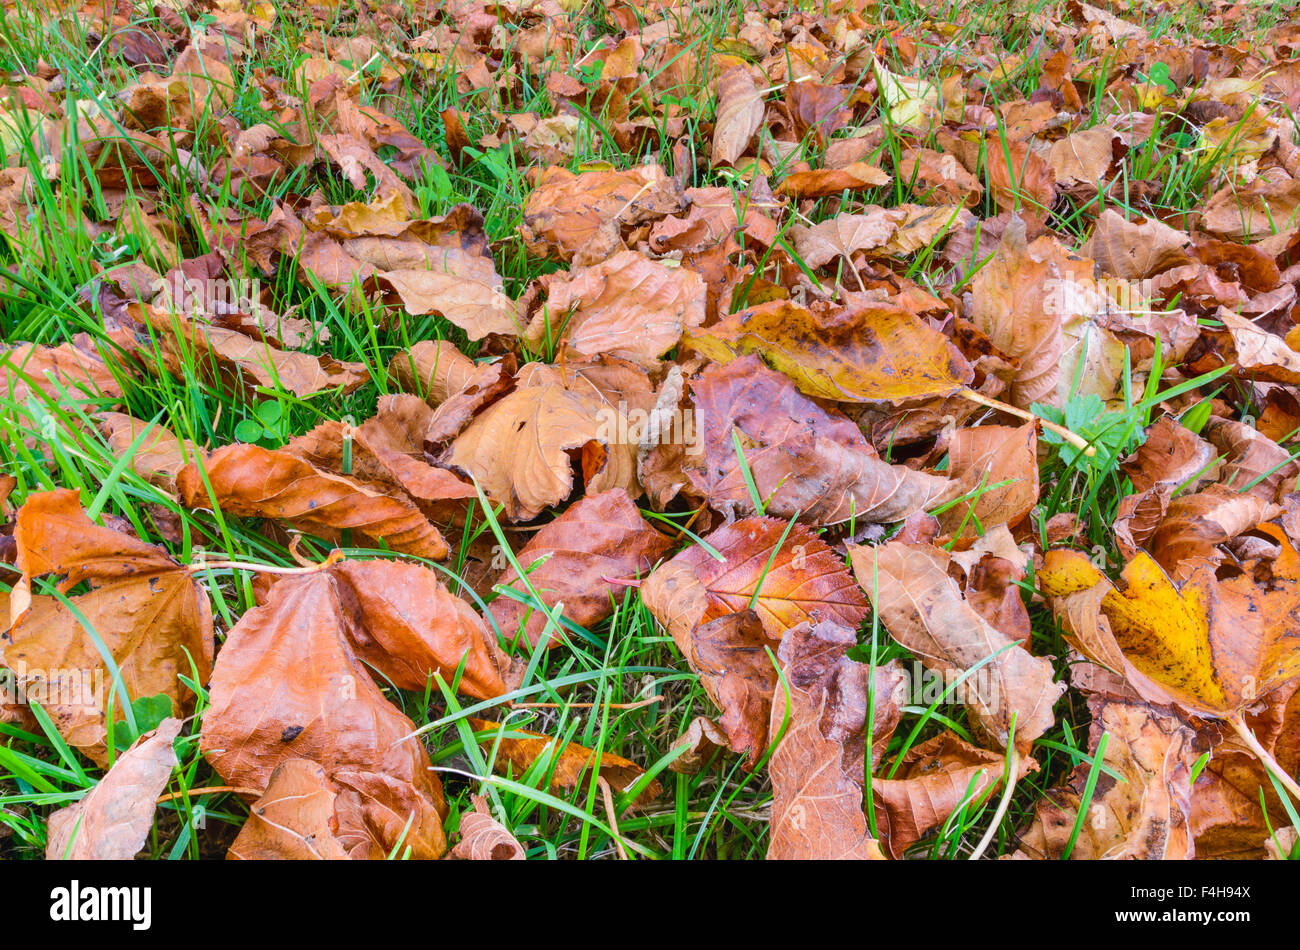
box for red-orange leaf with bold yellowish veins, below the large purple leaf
[641,517,867,641]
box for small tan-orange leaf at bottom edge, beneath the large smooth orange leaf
[226,759,348,860]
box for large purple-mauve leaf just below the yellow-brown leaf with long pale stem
[681,355,958,525]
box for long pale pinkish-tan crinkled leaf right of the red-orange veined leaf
[849,541,1066,750]
